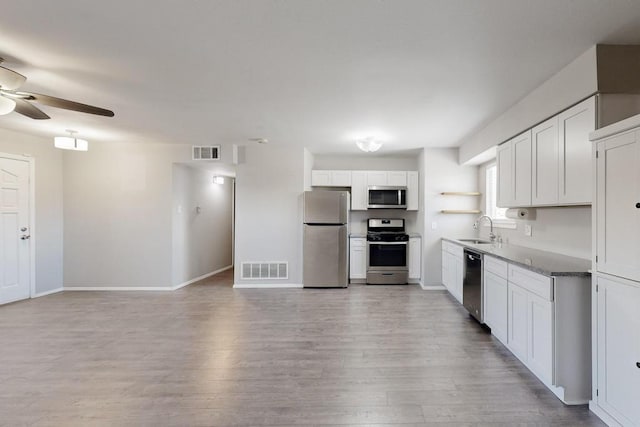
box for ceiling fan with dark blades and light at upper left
[0,58,113,120]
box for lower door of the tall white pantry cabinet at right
[596,277,640,426]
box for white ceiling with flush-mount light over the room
[0,0,640,154]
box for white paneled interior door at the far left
[0,157,31,304]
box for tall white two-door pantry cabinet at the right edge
[590,115,640,426]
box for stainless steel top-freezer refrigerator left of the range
[303,190,349,288]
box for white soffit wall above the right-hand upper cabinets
[459,46,598,163]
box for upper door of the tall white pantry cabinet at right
[596,132,640,281]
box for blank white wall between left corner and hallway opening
[64,143,191,287]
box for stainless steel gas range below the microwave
[367,218,409,285]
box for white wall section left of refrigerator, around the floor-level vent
[235,144,305,286]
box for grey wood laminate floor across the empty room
[0,271,603,426]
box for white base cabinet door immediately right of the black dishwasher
[484,270,508,344]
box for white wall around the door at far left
[0,129,63,294]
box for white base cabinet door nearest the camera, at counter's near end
[527,293,553,384]
